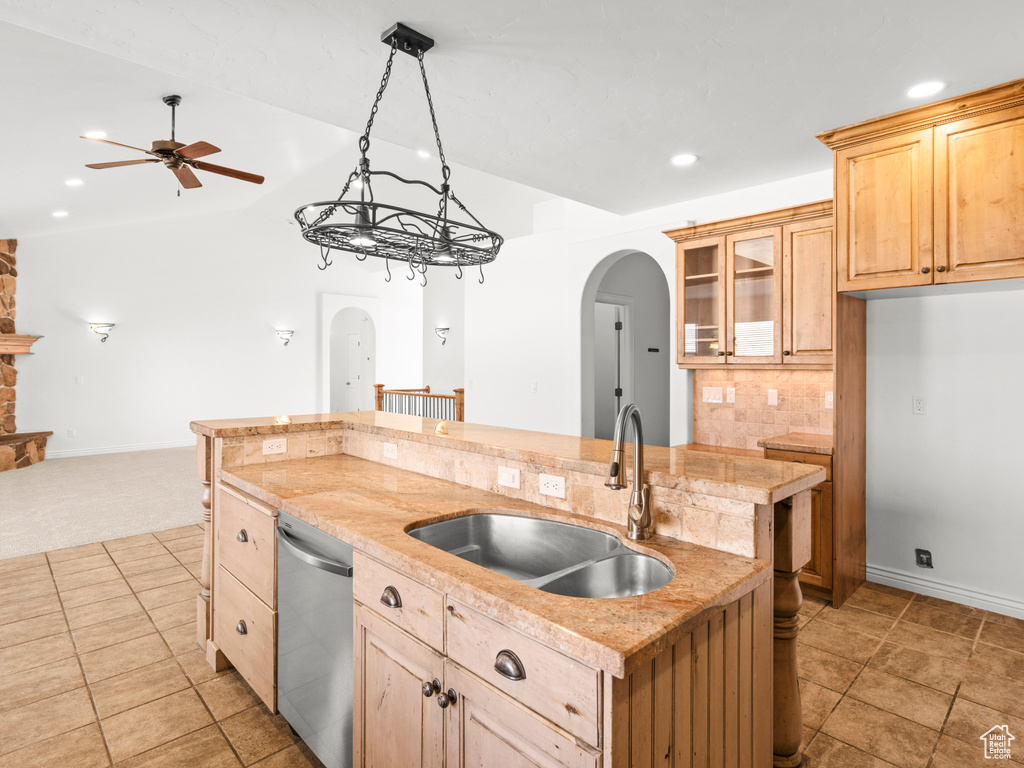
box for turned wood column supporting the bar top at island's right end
[772,490,811,768]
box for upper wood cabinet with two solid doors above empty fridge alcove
[818,81,1024,291]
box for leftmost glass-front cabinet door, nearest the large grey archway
[676,238,727,365]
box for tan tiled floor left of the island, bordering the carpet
[0,525,318,768]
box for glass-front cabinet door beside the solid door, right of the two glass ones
[726,227,782,365]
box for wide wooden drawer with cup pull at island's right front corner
[446,600,601,746]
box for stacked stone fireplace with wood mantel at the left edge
[0,240,53,472]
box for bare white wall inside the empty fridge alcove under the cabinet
[867,281,1024,617]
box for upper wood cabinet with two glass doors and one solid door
[666,201,835,368]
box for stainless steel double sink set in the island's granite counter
[409,510,674,597]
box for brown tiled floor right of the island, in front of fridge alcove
[797,584,1024,768]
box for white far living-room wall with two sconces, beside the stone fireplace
[17,207,422,457]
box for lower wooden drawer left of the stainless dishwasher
[213,566,278,712]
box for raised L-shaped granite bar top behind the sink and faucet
[190,411,824,504]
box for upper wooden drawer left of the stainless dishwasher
[216,488,278,609]
